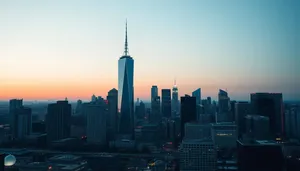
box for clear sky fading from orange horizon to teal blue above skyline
[0,0,300,100]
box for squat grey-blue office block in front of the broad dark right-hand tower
[245,115,270,140]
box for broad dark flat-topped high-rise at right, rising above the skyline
[251,93,284,138]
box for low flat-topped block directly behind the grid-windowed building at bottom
[184,123,212,139]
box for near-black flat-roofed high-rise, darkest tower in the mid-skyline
[180,95,197,140]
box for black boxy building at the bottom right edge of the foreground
[237,140,284,171]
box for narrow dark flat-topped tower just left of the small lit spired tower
[161,89,171,118]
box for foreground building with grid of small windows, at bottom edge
[179,139,217,171]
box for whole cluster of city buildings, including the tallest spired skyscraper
[0,24,300,171]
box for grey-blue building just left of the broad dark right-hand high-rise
[235,102,251,137]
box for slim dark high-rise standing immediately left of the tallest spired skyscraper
[107,88,119,140]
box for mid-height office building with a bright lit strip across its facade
[211,122,237,149]
